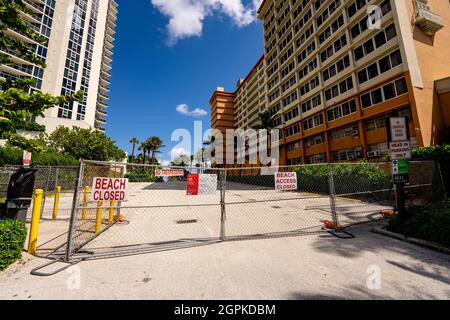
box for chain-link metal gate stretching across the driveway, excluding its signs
[47,161,444,261]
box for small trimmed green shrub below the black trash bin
[0,220,27,271]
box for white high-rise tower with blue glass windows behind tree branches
[0,0,117,132]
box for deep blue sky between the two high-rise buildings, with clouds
[106,0,263,160]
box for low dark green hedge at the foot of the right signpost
[388,201,450,247]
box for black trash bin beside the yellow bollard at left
[0,167,37,221]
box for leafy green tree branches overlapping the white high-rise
[0,0,83,152]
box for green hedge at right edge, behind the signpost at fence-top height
[412,144,450,195]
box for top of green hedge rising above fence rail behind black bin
[0,146,78,166]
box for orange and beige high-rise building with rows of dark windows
[210,0,450,165]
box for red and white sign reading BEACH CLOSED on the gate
[90,177,128,201]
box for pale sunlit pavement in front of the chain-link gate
[0,225,450,299]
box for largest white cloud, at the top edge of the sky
[151,0,262,44]
